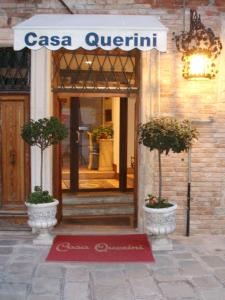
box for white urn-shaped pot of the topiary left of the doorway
[25,199,59,245]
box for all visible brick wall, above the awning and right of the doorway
[0,0,225,234]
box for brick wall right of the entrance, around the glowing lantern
[156,6,225,234]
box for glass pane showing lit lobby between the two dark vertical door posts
[79,98,119,190]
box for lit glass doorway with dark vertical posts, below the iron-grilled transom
[59,96,135,192]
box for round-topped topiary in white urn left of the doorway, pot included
[21,117,68,245]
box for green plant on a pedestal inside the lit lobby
[92,125,113,171]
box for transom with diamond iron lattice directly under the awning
[53,49,138,93]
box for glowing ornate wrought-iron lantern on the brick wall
[174,10,222,79]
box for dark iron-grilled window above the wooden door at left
[0,47,31,91]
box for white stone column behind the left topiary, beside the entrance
[30,48,53,193]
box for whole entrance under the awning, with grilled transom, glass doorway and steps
[52,49,139,226]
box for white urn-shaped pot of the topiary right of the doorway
[144,203,177,250]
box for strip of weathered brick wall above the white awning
[0,0,225,22]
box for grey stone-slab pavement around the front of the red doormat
[0,232,225,300]
